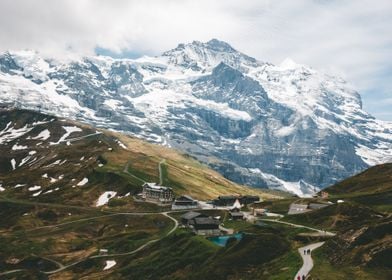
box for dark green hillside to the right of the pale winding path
[284,164,392,279]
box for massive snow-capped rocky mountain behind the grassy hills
[0,39,392,195]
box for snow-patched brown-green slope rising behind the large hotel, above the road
[0,107,274,207]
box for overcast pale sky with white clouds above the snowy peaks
[0,0,392,120]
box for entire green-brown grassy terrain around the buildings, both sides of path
[0,107,392,280]
